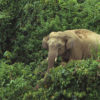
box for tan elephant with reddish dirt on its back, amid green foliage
[42,29,100,70]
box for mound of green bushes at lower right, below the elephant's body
[32,59,100,100]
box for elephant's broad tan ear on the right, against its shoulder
[66,38,82,59]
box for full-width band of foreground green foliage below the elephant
[0,59,100,100]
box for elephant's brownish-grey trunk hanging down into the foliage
[48,48,58,70]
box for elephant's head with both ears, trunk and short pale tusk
[42,31,81,69]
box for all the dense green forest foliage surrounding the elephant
[0,0,100,100]
